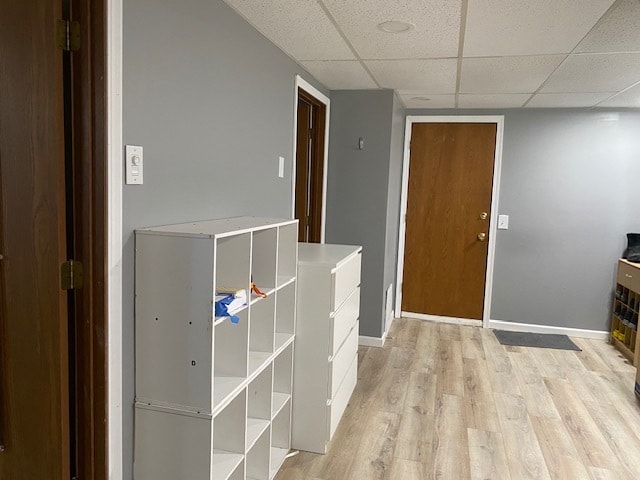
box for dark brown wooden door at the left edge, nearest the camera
[0,0,70,480]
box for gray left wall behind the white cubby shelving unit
[122,0,328,479]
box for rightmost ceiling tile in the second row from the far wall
[540,53,640,93]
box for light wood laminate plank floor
[276,319,640,480]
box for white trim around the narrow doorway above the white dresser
[291,75,331,243]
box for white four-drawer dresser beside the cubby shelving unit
[291,243,362,453]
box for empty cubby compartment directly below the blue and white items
[213,309,249,410]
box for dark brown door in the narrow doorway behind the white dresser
[295,89,326,243]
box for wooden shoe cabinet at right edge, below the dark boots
[611,259,640,366]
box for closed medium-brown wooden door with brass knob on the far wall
[402,123,496,320]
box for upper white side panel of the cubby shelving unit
[135,234,213,412]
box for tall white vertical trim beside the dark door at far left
[106,0,123,480]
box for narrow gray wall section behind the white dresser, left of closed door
[326,90,397,337]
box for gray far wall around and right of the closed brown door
[407,109,640,330]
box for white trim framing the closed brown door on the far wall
[395,115,504,328]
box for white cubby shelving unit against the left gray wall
[134,217,298,480]
